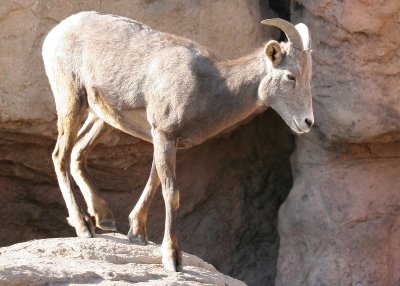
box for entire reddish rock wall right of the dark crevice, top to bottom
[276,0,400,285]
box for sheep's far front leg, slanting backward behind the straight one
[128,159,160,245]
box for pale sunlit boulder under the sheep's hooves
[0,234,245,286]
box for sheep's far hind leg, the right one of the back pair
[71,112,116,231]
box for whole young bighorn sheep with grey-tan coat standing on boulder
[42,12,314,271]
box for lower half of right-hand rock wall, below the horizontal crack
[276,132,400,285]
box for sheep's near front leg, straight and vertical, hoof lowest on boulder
[153,130,182,271]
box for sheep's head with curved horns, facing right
[258,19,314,134]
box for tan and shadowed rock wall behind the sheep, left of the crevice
[0,0,294,285]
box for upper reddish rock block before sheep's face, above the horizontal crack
[291,0,400,142]
